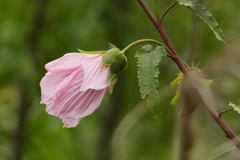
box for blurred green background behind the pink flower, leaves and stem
[0,0,240,160]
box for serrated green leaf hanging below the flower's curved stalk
[135,45,167,99]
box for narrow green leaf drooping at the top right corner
[178,0,226,43]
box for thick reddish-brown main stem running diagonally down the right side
[137,0,240,150]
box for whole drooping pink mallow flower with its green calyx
[40,45,127,128]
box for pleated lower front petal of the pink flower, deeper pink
[42,65,108,127]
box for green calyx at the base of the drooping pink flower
[101,44,127,81]
